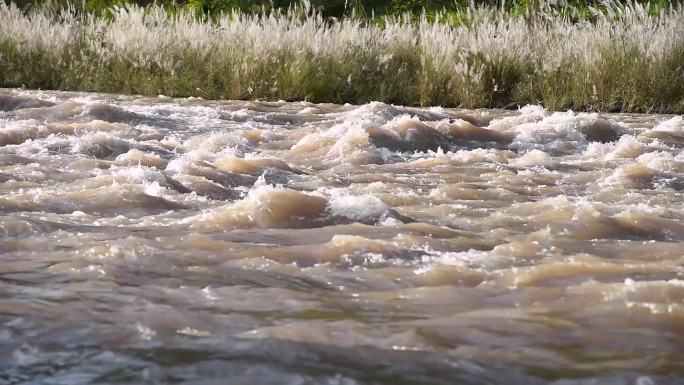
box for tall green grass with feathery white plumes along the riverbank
[0,3,684,113]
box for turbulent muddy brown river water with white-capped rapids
[0,90,684,385]
